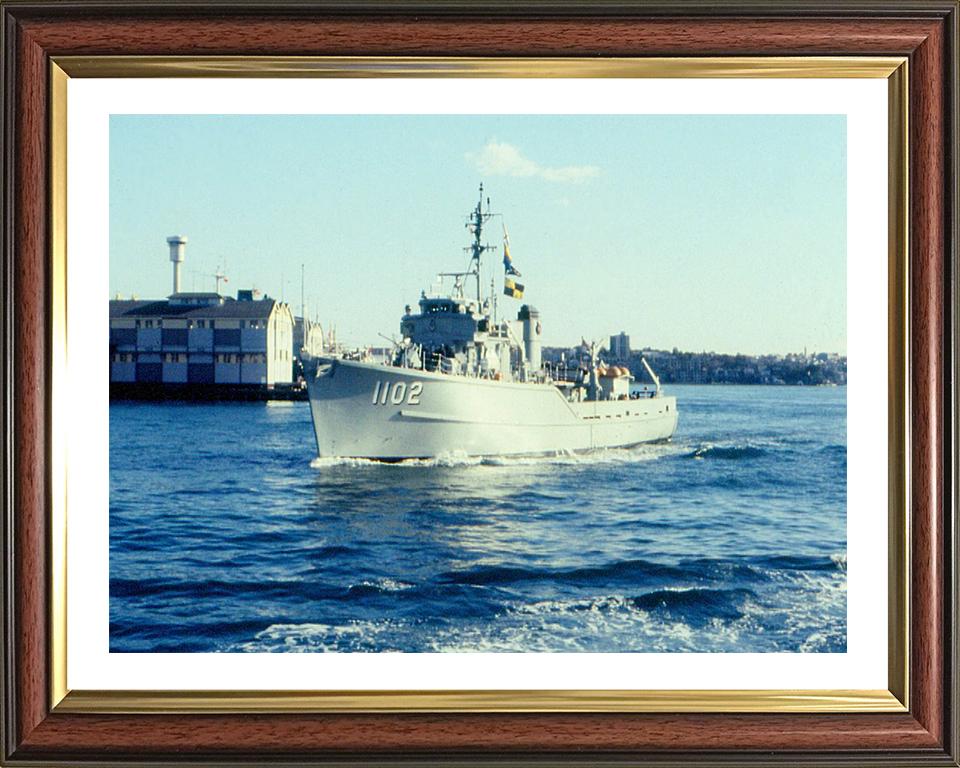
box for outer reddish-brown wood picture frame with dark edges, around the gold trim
[0,0,960,766]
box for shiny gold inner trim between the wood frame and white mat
[49,56,910,714]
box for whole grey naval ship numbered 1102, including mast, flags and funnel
[304,185,677,461]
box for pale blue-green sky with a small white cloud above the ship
[110,115,847,354]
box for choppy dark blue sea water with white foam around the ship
[110,386,847,652]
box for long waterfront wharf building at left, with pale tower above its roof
[110,236,294,394]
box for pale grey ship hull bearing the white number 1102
[306,359,677,461]
